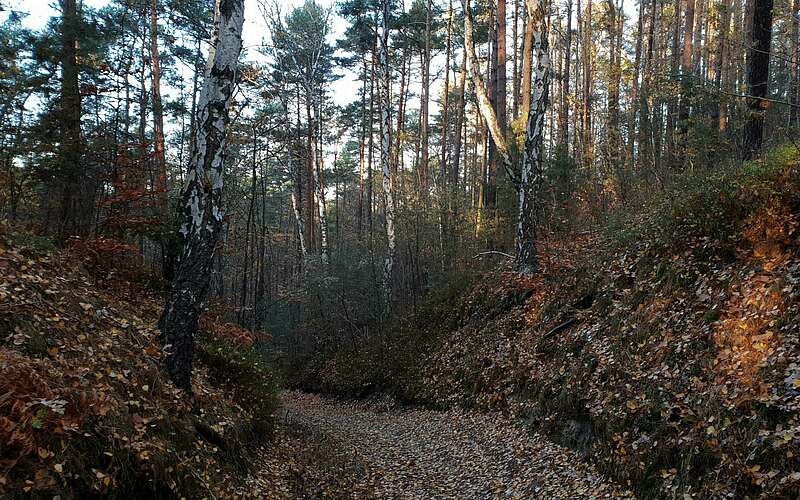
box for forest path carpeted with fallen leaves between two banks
[274,392,629,499]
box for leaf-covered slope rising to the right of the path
[297,148,800,498]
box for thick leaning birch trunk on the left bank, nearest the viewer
[161,0,244,390]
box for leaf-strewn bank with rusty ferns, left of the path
[0,232,288,499]
